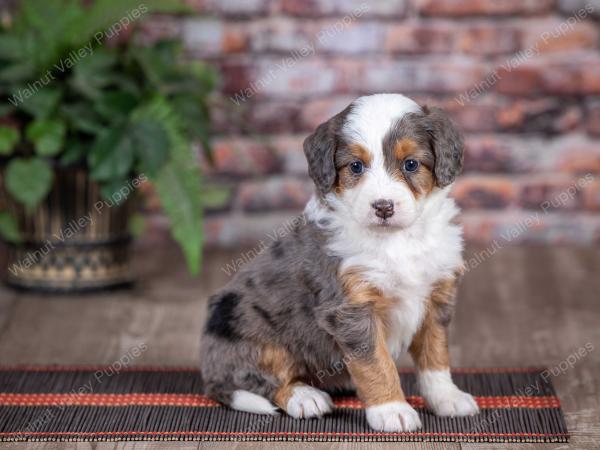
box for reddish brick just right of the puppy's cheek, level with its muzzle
[452,175,515,209]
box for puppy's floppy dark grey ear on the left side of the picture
[303,107,350,196]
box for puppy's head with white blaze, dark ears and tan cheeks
[304,94,463,228]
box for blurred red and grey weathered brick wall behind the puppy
[146,0,600,245]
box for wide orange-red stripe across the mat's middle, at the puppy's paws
[0,392,560,409]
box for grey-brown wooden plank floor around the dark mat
[0,244,600,450]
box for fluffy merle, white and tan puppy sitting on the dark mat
[201,94,478,432]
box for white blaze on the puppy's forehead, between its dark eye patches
[342,94,421,159]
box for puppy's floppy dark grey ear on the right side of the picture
[423,106,464,188]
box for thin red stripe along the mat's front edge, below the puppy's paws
[0,431,569,438]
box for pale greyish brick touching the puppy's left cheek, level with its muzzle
[234,177,314,212]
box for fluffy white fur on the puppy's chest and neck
[306,189,462,359]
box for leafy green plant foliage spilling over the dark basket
[0,0,216,274]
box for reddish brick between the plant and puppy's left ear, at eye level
[204,138,280,176]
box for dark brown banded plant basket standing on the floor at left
[2,168,133,292]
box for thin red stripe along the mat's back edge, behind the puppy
[0,365,547,374]
